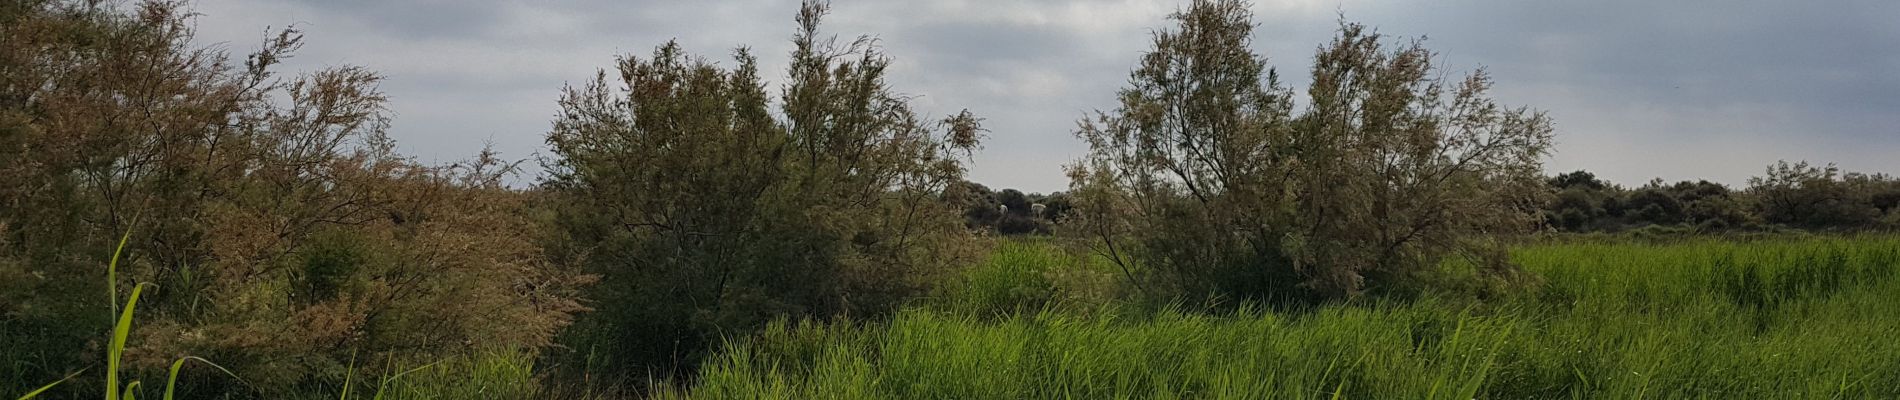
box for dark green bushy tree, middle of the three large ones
[542,2,982,379]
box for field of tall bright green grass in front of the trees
[642,237,1900,398]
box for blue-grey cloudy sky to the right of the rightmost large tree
[1276,0,1900,184]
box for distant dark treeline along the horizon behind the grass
[958,161,1900,235]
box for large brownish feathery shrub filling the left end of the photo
[0,2,580,391]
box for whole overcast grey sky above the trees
[192,0,1900,191]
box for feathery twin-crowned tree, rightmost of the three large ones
[1072,0,1550,300]
